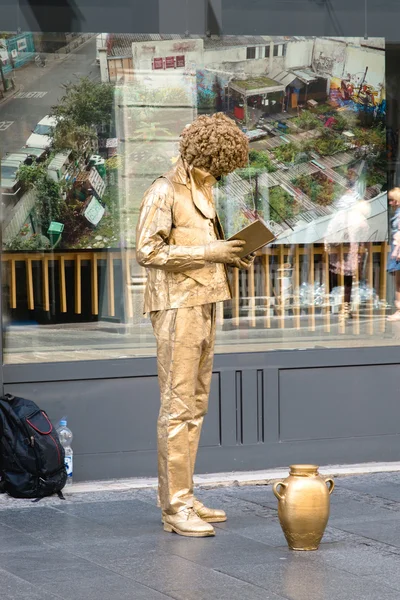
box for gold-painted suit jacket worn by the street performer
[136,159,232,313]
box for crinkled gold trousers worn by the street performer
[150,304,215,514]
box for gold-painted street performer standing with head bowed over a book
[136,113,254,537]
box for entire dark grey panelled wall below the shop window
[3,347,400,480]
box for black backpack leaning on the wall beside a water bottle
[0,394,67,499]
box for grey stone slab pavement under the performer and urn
[0,473,400,600]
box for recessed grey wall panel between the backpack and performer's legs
[5,377,159,454]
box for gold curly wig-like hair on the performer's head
[180,113,249,177]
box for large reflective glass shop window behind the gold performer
[0,32,400,363]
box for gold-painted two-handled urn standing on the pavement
[273,465,335,550]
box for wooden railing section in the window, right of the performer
[232,242,389,335]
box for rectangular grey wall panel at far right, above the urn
[279,365,400,441]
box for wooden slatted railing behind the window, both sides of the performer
[2,242,388,335]
